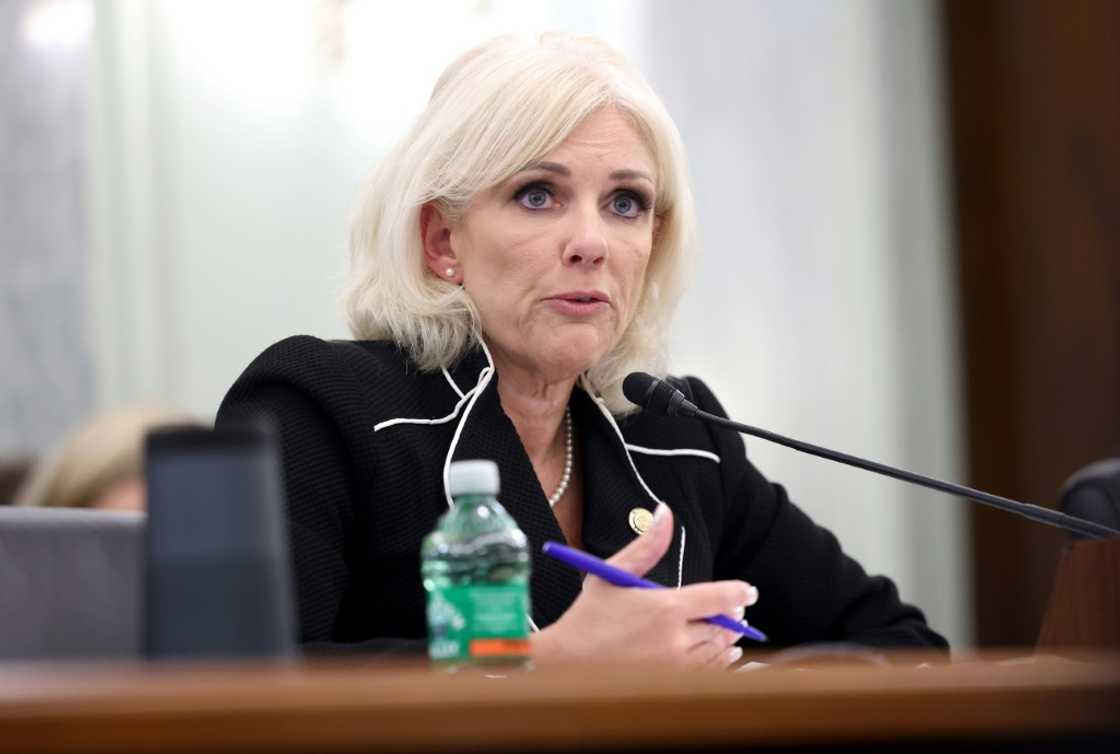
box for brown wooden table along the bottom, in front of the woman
[0,654,1120,754]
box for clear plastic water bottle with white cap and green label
[420,460,530,668]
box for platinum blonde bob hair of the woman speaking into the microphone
[344,34,696,415]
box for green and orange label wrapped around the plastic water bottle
[428,584,529,661]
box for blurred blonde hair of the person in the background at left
[13,406,196,508]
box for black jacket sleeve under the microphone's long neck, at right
[688,378,949,649]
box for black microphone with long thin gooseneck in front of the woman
[623,372,1120,539]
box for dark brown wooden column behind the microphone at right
[943,0,1120,645]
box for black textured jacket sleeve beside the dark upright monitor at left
[215,337,426,654]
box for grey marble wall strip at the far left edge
[0,0,94,452]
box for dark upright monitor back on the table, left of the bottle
[144,425,296,658]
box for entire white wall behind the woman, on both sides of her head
[91,0,970,643]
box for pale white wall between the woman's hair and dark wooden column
[642,0,971,645]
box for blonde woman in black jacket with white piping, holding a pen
[217,35,944,667]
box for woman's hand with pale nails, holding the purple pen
[531,503,758,669]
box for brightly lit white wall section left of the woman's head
[91,0,594,416]
